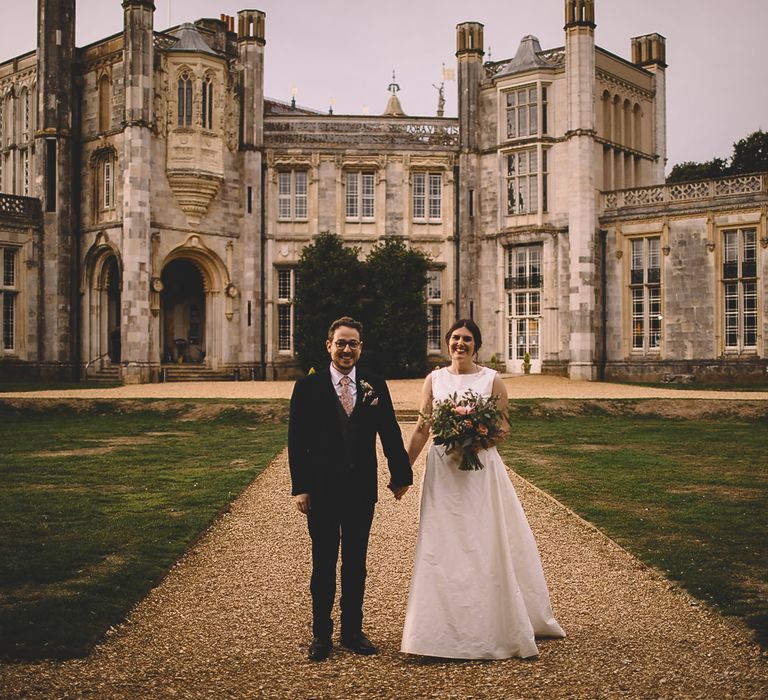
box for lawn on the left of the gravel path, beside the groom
[0,401,286,659]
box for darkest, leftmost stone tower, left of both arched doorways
[35,0,79,376]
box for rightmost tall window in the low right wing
[723,228,758,352]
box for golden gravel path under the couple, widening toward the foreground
[0,424,768,700]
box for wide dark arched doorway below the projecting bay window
[160,258,206,364]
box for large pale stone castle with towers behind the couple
[0,0,768,383]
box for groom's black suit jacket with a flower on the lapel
[288,367,413,502]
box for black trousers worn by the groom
[307,497,375,639]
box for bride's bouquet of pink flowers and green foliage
[422,389,502,471]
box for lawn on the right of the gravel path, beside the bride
[501,402,768,646]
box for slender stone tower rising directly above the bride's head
[456,22,484,318]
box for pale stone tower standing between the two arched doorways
[121,0,158,383]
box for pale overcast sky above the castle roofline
[0,0,768,171]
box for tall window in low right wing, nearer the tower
[629,237,661,354]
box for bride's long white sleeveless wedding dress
[401,367,565,659]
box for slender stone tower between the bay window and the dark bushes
[237,10,266,378]
